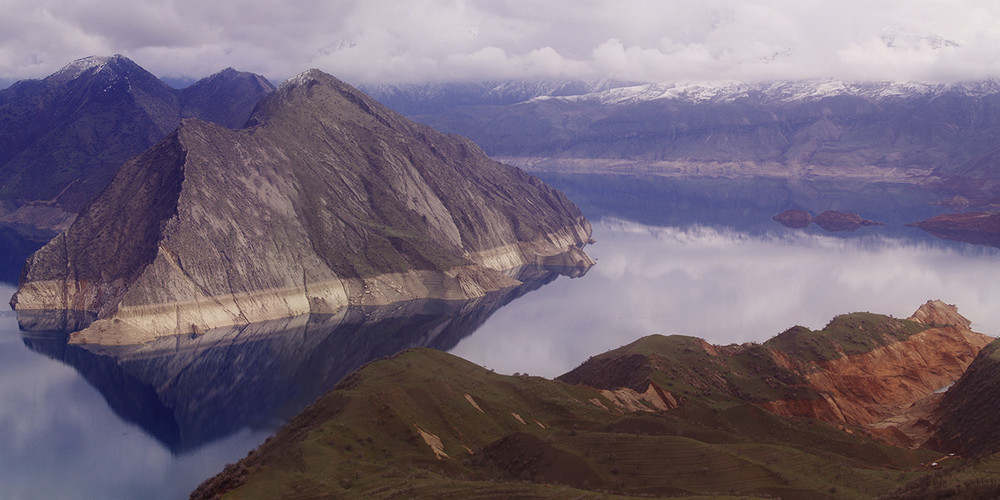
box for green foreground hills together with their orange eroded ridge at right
[192,301,986,499]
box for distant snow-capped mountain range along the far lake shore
[374,80,1000,197]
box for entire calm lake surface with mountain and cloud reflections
[0,176,1000,498]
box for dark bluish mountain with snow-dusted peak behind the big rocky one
[0,55,273,237]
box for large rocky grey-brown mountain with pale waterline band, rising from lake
[11,70,592,343]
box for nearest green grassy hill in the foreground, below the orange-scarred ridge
[195,348,933,498]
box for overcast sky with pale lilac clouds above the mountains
[0,0,1000,83]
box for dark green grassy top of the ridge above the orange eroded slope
[559,313,928,408]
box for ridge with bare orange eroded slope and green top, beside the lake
[559,301,991,446]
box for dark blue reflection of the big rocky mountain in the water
[15,268,576,453]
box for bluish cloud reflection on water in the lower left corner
[0,294,269,499]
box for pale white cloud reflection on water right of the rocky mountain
[451,218,1000,377]
